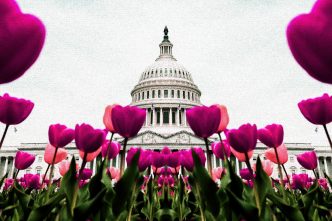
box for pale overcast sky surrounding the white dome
[0,0,332,148]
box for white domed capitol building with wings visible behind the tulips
[0,27,332,178]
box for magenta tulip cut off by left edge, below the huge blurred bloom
[0,93,34,125]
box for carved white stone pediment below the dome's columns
[128,130,205,148]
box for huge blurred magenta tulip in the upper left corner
[0,0,46,84]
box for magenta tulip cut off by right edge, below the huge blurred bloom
[298,94,332,125]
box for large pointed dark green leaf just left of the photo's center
[112,151,140,216]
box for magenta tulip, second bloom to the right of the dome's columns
[226,124,257,153]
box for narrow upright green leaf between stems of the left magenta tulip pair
[61,157,78,211]
